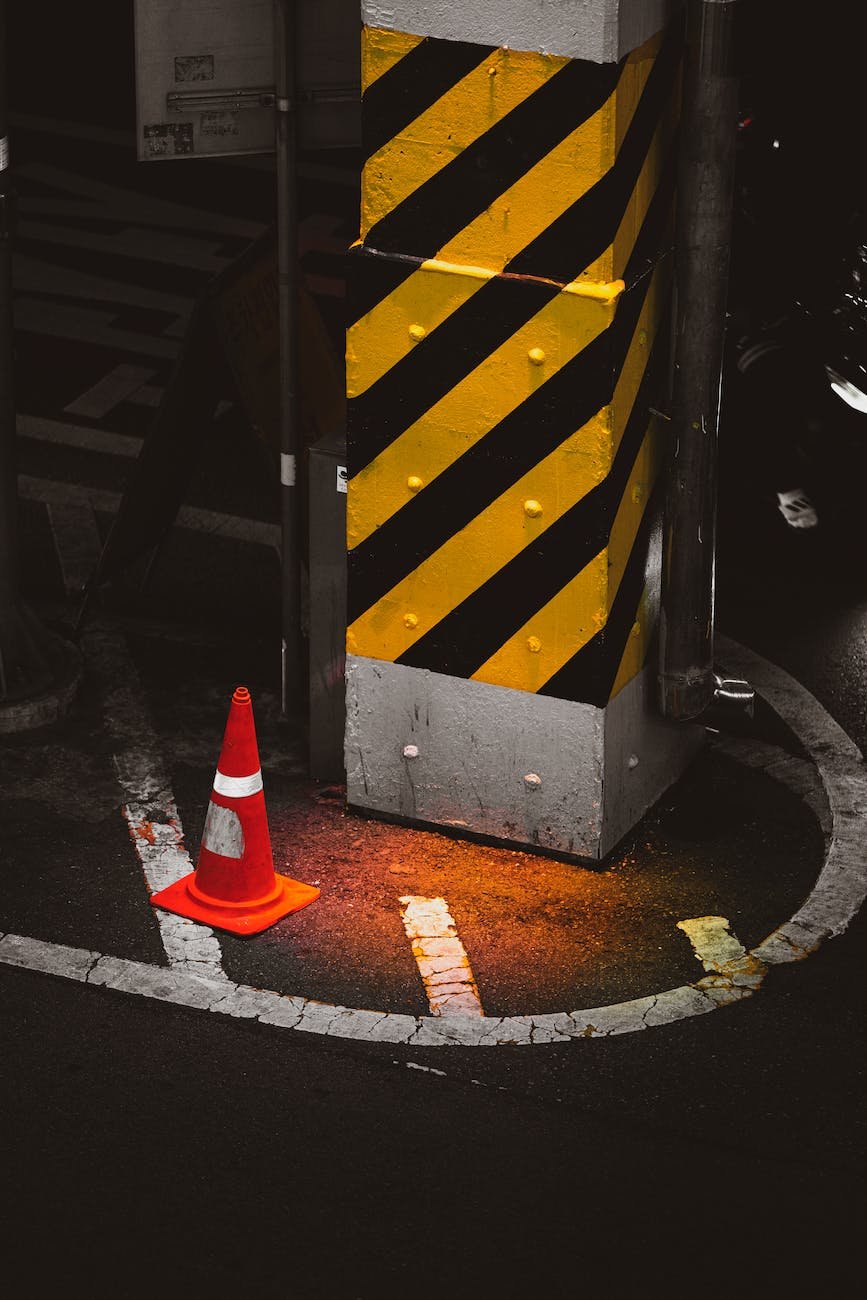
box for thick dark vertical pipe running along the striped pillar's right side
[659,0,737,720]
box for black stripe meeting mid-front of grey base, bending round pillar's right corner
[398,320,668,677]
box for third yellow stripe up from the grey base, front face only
[347,286,623,550]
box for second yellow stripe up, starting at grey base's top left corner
[347,269,667,670]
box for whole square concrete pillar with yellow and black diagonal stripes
[346,0,697,858]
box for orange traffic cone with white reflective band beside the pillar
[151,686,320,935]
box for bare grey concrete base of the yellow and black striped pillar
[346,655,705,861]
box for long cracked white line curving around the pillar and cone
[0,638,867,1047]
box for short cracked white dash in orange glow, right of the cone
[400,894,485,1015]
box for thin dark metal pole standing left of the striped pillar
[274,0,303,714]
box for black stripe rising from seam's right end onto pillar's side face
[508,22,682,283]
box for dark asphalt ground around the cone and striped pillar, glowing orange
[0,4,867,1300]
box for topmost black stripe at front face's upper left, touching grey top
[361,36,497,157]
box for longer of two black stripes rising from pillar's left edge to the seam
[347,270,562,477]
